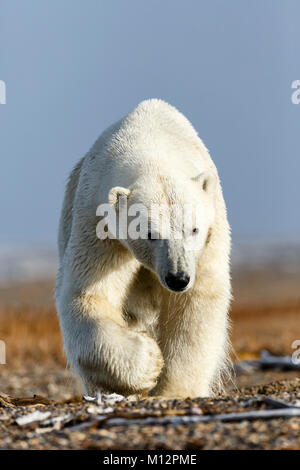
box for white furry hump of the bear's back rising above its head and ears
[92,99,216,180]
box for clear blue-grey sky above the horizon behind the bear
[0,0,300,244]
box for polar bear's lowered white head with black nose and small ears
[109,171,217,292]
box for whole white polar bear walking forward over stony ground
[56,99,231,397]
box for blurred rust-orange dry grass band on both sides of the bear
[0,302,300,368]
